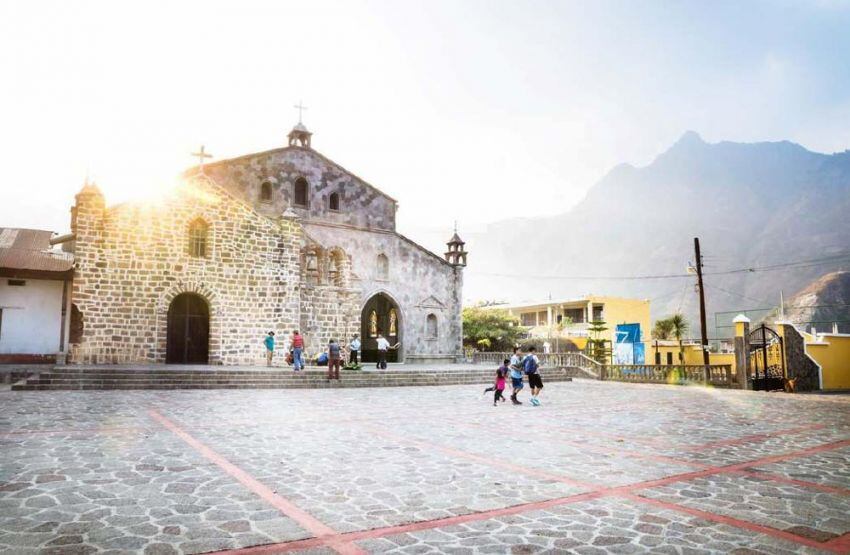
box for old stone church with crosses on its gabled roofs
[68,122,466,365]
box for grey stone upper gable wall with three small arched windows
[204,147,396,230]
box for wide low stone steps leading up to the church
[11,365,588,391]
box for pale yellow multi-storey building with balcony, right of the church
[488,295,650,348]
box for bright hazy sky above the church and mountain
[0,0,850,252]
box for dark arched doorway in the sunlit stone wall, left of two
[165,293,210,364]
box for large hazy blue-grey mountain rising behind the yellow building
[466,131,850,336]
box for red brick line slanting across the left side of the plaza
[148,409,364,554]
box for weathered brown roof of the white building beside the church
[0,227,74,272]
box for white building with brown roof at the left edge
[0,228,74,363]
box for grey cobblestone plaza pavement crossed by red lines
[0,380,850,554]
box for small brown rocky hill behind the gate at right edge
[785,272,850,333]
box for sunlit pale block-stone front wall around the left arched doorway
[71,178,303,364]
